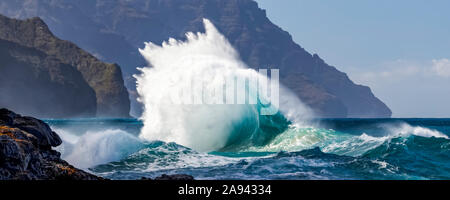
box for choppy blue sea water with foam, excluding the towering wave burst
[46,119,450,180]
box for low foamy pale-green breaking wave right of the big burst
[237,123,449,156]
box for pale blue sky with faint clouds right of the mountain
[256,0,450,118]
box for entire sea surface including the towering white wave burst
[46,19,450,179]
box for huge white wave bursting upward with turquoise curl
[135,19,311,152]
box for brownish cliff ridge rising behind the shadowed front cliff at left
[0,16,130,117]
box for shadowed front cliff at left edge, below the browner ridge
[0,39,97,118]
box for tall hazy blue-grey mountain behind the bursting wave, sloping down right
[0,0,391,117]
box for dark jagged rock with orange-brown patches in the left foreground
[0,109,102,180]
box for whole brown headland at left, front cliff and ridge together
[0,15,130,118]
